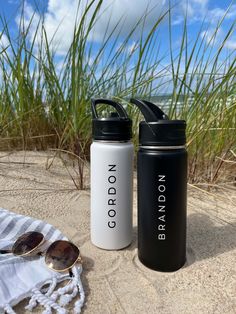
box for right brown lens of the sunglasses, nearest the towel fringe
[45,240,80,271]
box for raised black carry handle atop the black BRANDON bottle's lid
[130,98,169,122]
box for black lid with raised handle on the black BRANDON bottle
[130,98,186,146]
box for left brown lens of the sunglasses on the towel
[12,231,44,255]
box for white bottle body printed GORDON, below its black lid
[91,141,134,250]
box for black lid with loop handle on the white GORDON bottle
[91,98,132,142]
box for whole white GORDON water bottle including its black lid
[90,99,134,250]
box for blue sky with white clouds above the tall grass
[0,0,236,93]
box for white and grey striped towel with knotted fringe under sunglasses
[0,208,85,314]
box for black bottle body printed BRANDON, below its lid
[137,147,187,271]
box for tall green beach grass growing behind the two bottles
[0,0,236,186]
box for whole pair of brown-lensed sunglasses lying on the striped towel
[0,231,82,274]
